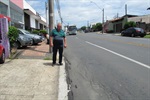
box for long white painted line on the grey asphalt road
[85,41,150,69]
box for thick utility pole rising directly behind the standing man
[48,0,54,53]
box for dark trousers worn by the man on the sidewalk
[53,45,63,64]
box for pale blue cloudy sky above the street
[26,0,150,28]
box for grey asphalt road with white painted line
[64,33,150,100]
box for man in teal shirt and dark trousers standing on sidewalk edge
[50,23,67,65]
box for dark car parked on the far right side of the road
[121,27,146,37]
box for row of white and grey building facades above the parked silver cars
[0,0,47,30]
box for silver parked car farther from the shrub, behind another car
[18,29,42,44]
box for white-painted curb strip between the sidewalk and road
[58,58,69,100]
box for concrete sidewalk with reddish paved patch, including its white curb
[0,42,68,100]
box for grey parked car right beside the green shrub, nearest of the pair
[15,34,33,48]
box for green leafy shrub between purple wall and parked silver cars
[8,26,19,47]
